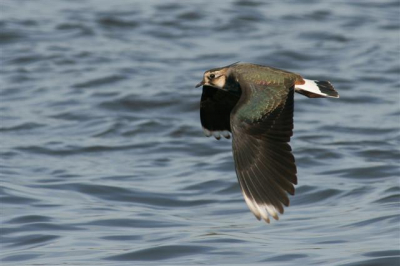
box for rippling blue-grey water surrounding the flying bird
[0,0,400,266]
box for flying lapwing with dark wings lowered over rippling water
[195,62,339,223]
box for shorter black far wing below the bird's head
[200,86,240,139]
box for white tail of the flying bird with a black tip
[294,79,339,98]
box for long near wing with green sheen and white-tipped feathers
[231,84,297,223]
